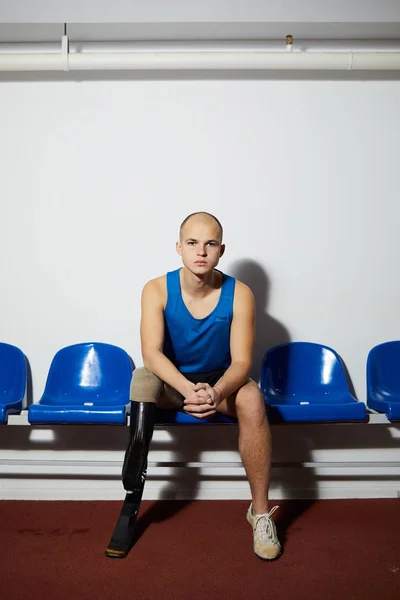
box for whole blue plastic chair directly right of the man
[260,342,367,422]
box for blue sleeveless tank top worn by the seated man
[163,269,235,373]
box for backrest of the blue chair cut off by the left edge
[0,342,26,403]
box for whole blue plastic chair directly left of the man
[28,343,134,425]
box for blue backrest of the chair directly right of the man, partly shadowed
[260,342,348,397]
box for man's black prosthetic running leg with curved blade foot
[105,402,156,558]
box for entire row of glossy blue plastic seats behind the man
[0,341,400,424]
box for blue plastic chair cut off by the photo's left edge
[0,342,26,423]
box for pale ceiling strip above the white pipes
[0,0,400,43]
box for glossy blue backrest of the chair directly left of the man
[44,342,133,403]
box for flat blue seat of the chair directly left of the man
[28,402,129,425]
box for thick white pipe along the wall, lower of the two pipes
[0,45,400,71]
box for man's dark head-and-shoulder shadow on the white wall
[229,259,290,381]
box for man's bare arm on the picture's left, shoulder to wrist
[140,278,193,398]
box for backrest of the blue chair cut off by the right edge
[367,340,400,394]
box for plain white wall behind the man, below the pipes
[0,81,400,400]
